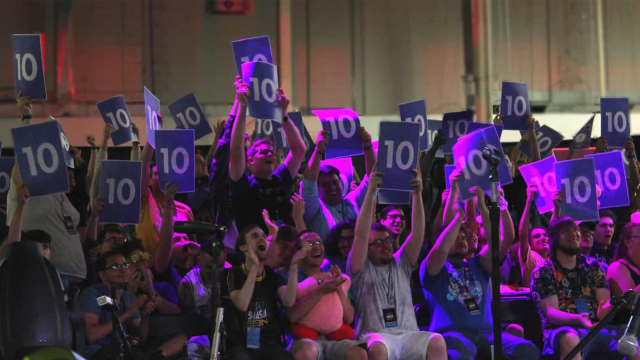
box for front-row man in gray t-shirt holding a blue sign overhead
[347,171,447,360]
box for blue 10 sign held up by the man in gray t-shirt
[378,121,420,191]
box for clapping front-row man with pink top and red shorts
[287,232,367,360]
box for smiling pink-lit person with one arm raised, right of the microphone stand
[518,185,549,288]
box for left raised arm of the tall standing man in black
[229,79,251,181]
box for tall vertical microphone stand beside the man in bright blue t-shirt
[487,161,502,360]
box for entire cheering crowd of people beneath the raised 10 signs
[0,79,640,360]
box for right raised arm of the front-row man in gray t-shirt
[400,166,425,268]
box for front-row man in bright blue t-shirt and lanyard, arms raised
[420,169,539,360]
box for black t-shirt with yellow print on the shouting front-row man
[220,265,286,349]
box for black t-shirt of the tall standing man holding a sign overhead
[230,164,294,231]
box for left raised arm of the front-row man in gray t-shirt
[348,167,384,276]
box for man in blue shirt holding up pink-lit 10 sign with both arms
[302,127,376,239]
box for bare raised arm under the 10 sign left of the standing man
[153,181,180,274]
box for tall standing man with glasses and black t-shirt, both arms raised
[229,80,306,235]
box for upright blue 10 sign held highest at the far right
[600,98,631,148]
